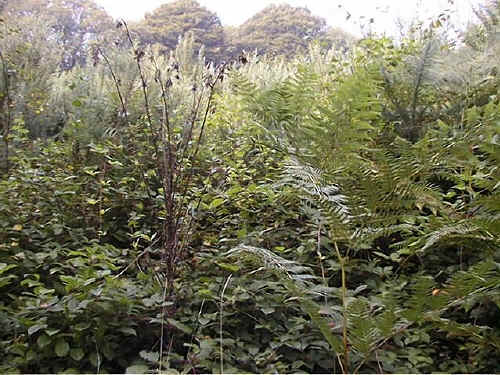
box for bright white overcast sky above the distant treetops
[96,0,487,35]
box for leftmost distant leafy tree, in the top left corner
[2,0,113,69]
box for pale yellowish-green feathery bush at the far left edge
[0,15,64,141]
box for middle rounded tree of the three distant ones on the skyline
[135,0,224,61]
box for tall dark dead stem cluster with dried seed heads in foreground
[105,20,228,372]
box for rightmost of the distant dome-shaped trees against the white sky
[232,4,326,57]
